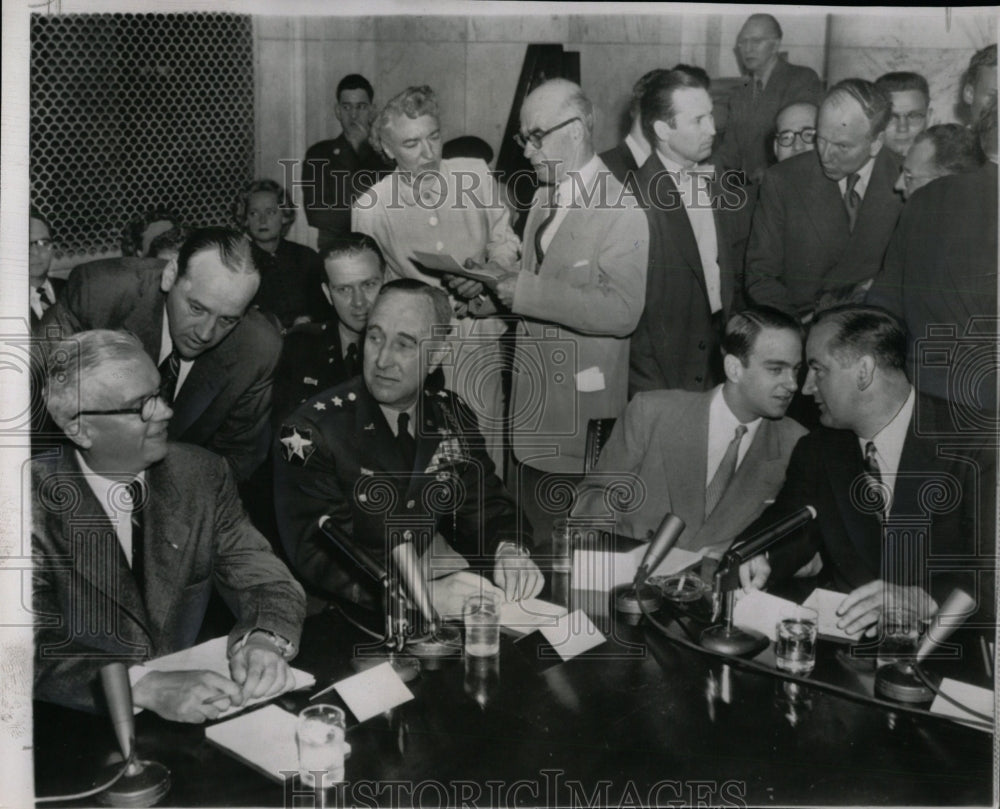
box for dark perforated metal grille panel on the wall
[30,14,254,256]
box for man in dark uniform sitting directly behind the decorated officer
[272,233,385,424]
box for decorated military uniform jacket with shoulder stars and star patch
[274,377,530,600]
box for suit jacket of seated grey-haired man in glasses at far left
[31,444,305,710]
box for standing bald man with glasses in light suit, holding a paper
[461,79,649,474]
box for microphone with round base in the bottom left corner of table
[99,662,170,806]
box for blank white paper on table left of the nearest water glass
[205,705,299,782]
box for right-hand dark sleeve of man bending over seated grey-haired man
[207,312,281,481]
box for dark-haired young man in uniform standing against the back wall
[301,73,389,250]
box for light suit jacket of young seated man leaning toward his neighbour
[574,389,806,550]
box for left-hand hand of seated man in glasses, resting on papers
[132,670,240,722]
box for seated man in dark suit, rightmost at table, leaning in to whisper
[740,305,995,634]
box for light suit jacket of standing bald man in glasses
[510,162,649,472]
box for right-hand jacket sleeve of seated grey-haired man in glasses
[201,458,306,648]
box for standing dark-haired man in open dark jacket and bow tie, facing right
[629,70,744,395]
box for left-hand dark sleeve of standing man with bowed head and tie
[746,171,795,314]
